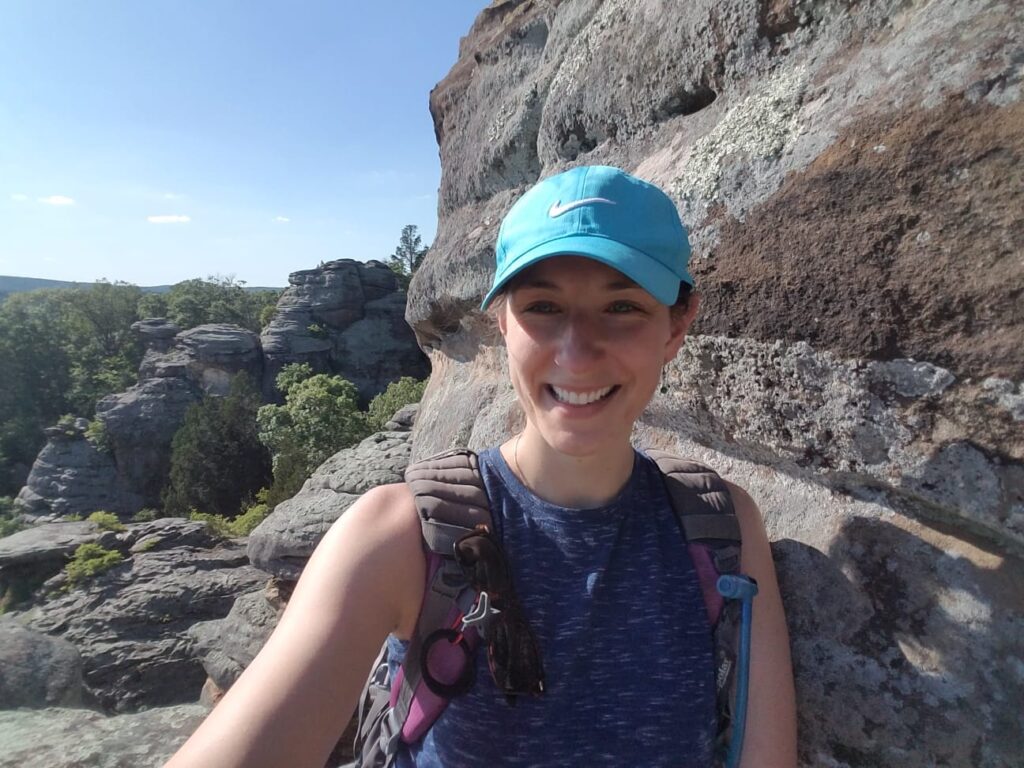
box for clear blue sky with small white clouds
[0,0,487,286]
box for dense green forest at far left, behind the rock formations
[0,278,280,495]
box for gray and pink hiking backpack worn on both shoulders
[352,449,750,768]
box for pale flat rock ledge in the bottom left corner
[0,703,209,768]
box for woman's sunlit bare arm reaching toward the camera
[165,484,426,768]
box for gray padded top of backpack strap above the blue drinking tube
[647,451,740,546]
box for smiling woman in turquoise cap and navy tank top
[168,167,796,768]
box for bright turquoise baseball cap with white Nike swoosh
[480,165,693,309]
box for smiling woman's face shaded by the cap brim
[498,256,697,457]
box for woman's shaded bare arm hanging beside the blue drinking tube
[729,483,797,768]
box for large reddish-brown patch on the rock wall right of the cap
[694,97,1024,380]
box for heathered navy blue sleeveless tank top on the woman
[389,449,716,768]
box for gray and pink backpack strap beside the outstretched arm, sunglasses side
[356,449,493,766]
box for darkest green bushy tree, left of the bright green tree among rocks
[164,374,270,518]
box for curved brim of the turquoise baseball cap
[480,234,693,310]
